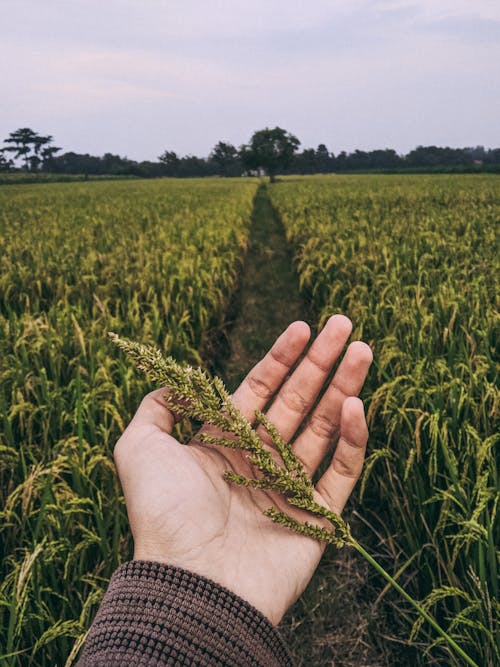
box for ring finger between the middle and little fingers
[294,341,373,476]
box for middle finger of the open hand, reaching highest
[258,315,352,444]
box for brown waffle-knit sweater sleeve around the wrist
[78,561,293,667]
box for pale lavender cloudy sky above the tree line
[0,0,500,160]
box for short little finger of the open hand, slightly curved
[316,396,368,514]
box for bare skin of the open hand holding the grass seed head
[115,315,372,625]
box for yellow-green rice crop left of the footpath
[0,180,257,667]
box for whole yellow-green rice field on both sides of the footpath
[0,175,500,667]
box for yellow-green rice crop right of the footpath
[271,176,500,665]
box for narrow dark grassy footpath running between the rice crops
[219,185,390,667]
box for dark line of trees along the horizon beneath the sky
[0,127,500,179]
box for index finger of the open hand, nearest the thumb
[232,321,311,421]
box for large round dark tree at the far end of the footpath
[240,127,300,183]
